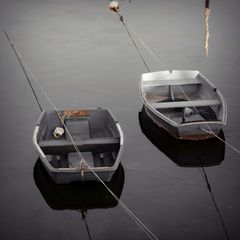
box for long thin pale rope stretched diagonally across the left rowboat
[4,30,159,240]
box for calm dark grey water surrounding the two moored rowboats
[0,0,240,240]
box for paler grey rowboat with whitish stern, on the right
[139,70,227,140]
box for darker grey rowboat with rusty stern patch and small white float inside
[33,108,124,183]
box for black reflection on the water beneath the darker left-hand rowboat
[33,159,125,211]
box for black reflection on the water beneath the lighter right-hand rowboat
[139,107,225,167]
